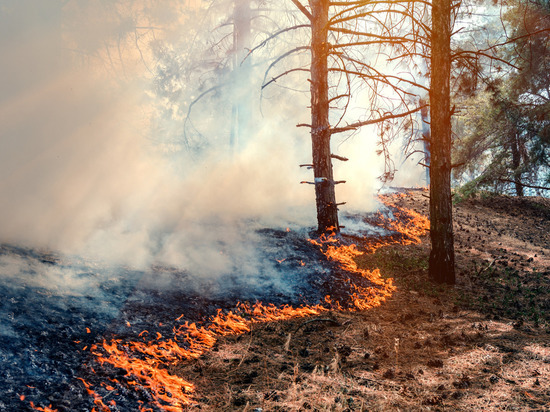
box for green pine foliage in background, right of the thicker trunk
[454,0,550,198]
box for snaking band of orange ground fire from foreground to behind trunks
[23,197,428,412]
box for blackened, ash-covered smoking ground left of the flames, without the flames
[0,223,388,411]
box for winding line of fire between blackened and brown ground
[27,198,429,412]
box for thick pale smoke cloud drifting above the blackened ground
[0,0,426,286]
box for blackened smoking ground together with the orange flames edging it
[0,195,408,411]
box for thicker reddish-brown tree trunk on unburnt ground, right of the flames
[429,0,455,284]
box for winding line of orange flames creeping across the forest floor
[71,196,429,412]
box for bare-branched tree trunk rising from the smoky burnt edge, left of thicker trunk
[309,0,339,233]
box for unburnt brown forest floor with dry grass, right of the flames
[174,190,550,412]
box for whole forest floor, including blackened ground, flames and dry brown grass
[2,190,550,411]
